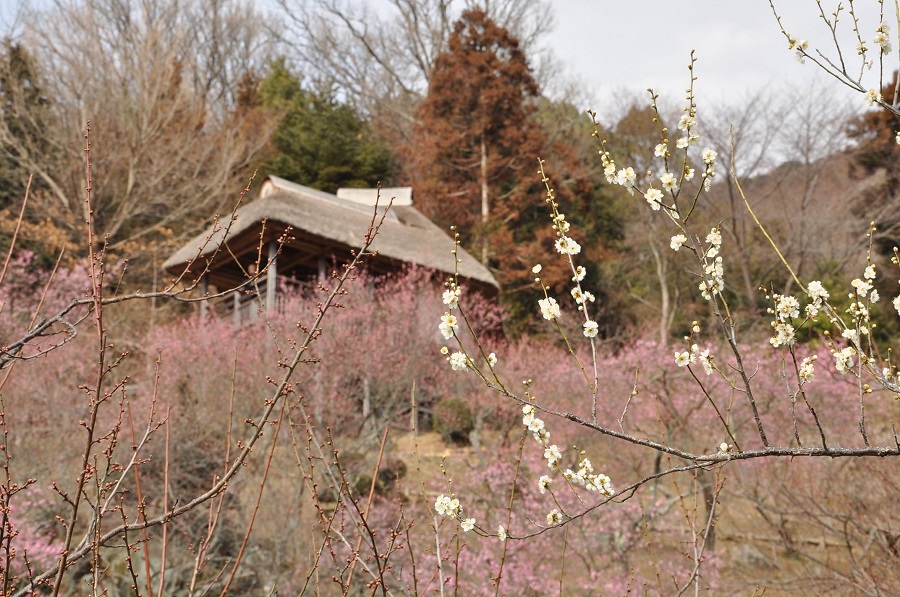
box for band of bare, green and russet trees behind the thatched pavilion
[0,0,888,340]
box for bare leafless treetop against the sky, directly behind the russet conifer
[278,0,553,138]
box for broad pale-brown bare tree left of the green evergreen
[0,0,272,246]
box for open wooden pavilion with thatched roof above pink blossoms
[163,176,498,321]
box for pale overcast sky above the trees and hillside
[0,0,884,114]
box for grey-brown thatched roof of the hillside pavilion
[163,176,498,289]
